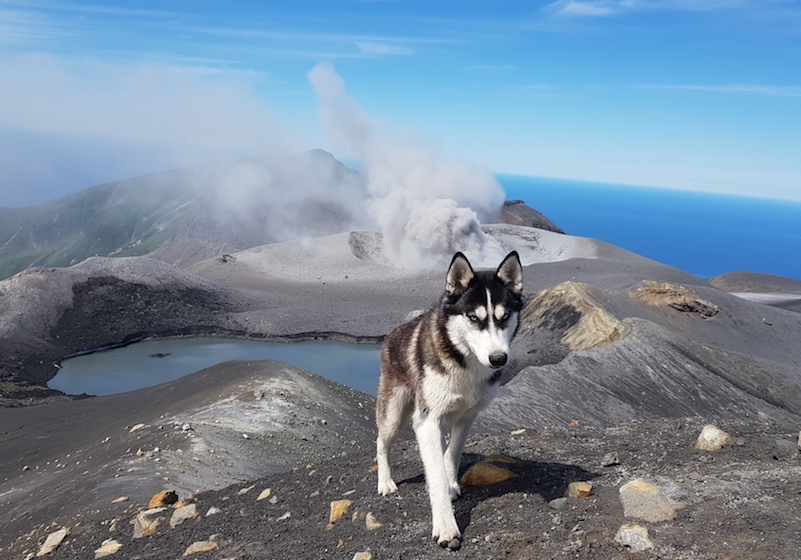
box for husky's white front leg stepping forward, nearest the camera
[414,414,462,548]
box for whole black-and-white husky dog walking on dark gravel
[376,251,523,548]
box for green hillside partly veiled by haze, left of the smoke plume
[0,150,363,279]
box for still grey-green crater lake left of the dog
[47,338,381,395]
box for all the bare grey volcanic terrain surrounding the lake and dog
[0,225,801,560]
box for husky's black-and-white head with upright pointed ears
[444,251,523,369]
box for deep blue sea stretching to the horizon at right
[497,175,801,280]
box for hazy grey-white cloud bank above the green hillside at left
[0,55,300,206]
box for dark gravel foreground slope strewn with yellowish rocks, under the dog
[6,418,801,560]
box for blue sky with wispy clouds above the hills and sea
[0,0,801,206]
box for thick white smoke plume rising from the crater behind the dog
[309,64,505,268]
